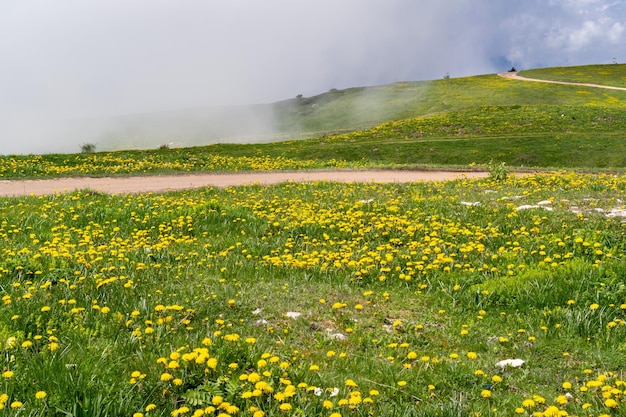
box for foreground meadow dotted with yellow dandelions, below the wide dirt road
[0,173,626,417]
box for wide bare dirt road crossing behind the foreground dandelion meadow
[0,170,489,197]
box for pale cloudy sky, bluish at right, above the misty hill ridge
[0,0,626,154]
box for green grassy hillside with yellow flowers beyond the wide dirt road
[0,65,626,178]
